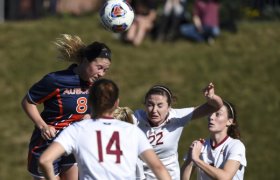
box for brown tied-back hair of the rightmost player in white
[223,100,241,139]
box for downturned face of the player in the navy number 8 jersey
[81,58,111,82]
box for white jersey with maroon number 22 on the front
[134,108,194,180]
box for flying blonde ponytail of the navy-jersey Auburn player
[54,34,86,64]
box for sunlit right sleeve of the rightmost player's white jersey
[228,140,247,166]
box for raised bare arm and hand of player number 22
[192,83,223,119]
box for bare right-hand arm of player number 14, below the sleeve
[140,149,171,180]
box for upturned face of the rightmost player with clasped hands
[208,106,231,133]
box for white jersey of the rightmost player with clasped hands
[197,137,247,180]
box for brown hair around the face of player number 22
[144,85,176,106]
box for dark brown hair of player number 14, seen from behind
[89,79,119,118]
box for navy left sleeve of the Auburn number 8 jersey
[27,74,56,104]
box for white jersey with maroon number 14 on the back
[55,119,152,180]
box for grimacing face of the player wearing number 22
[145,94,170,126]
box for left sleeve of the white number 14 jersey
[54,123,79,155]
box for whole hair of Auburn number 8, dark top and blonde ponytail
[54,34,111,64]
